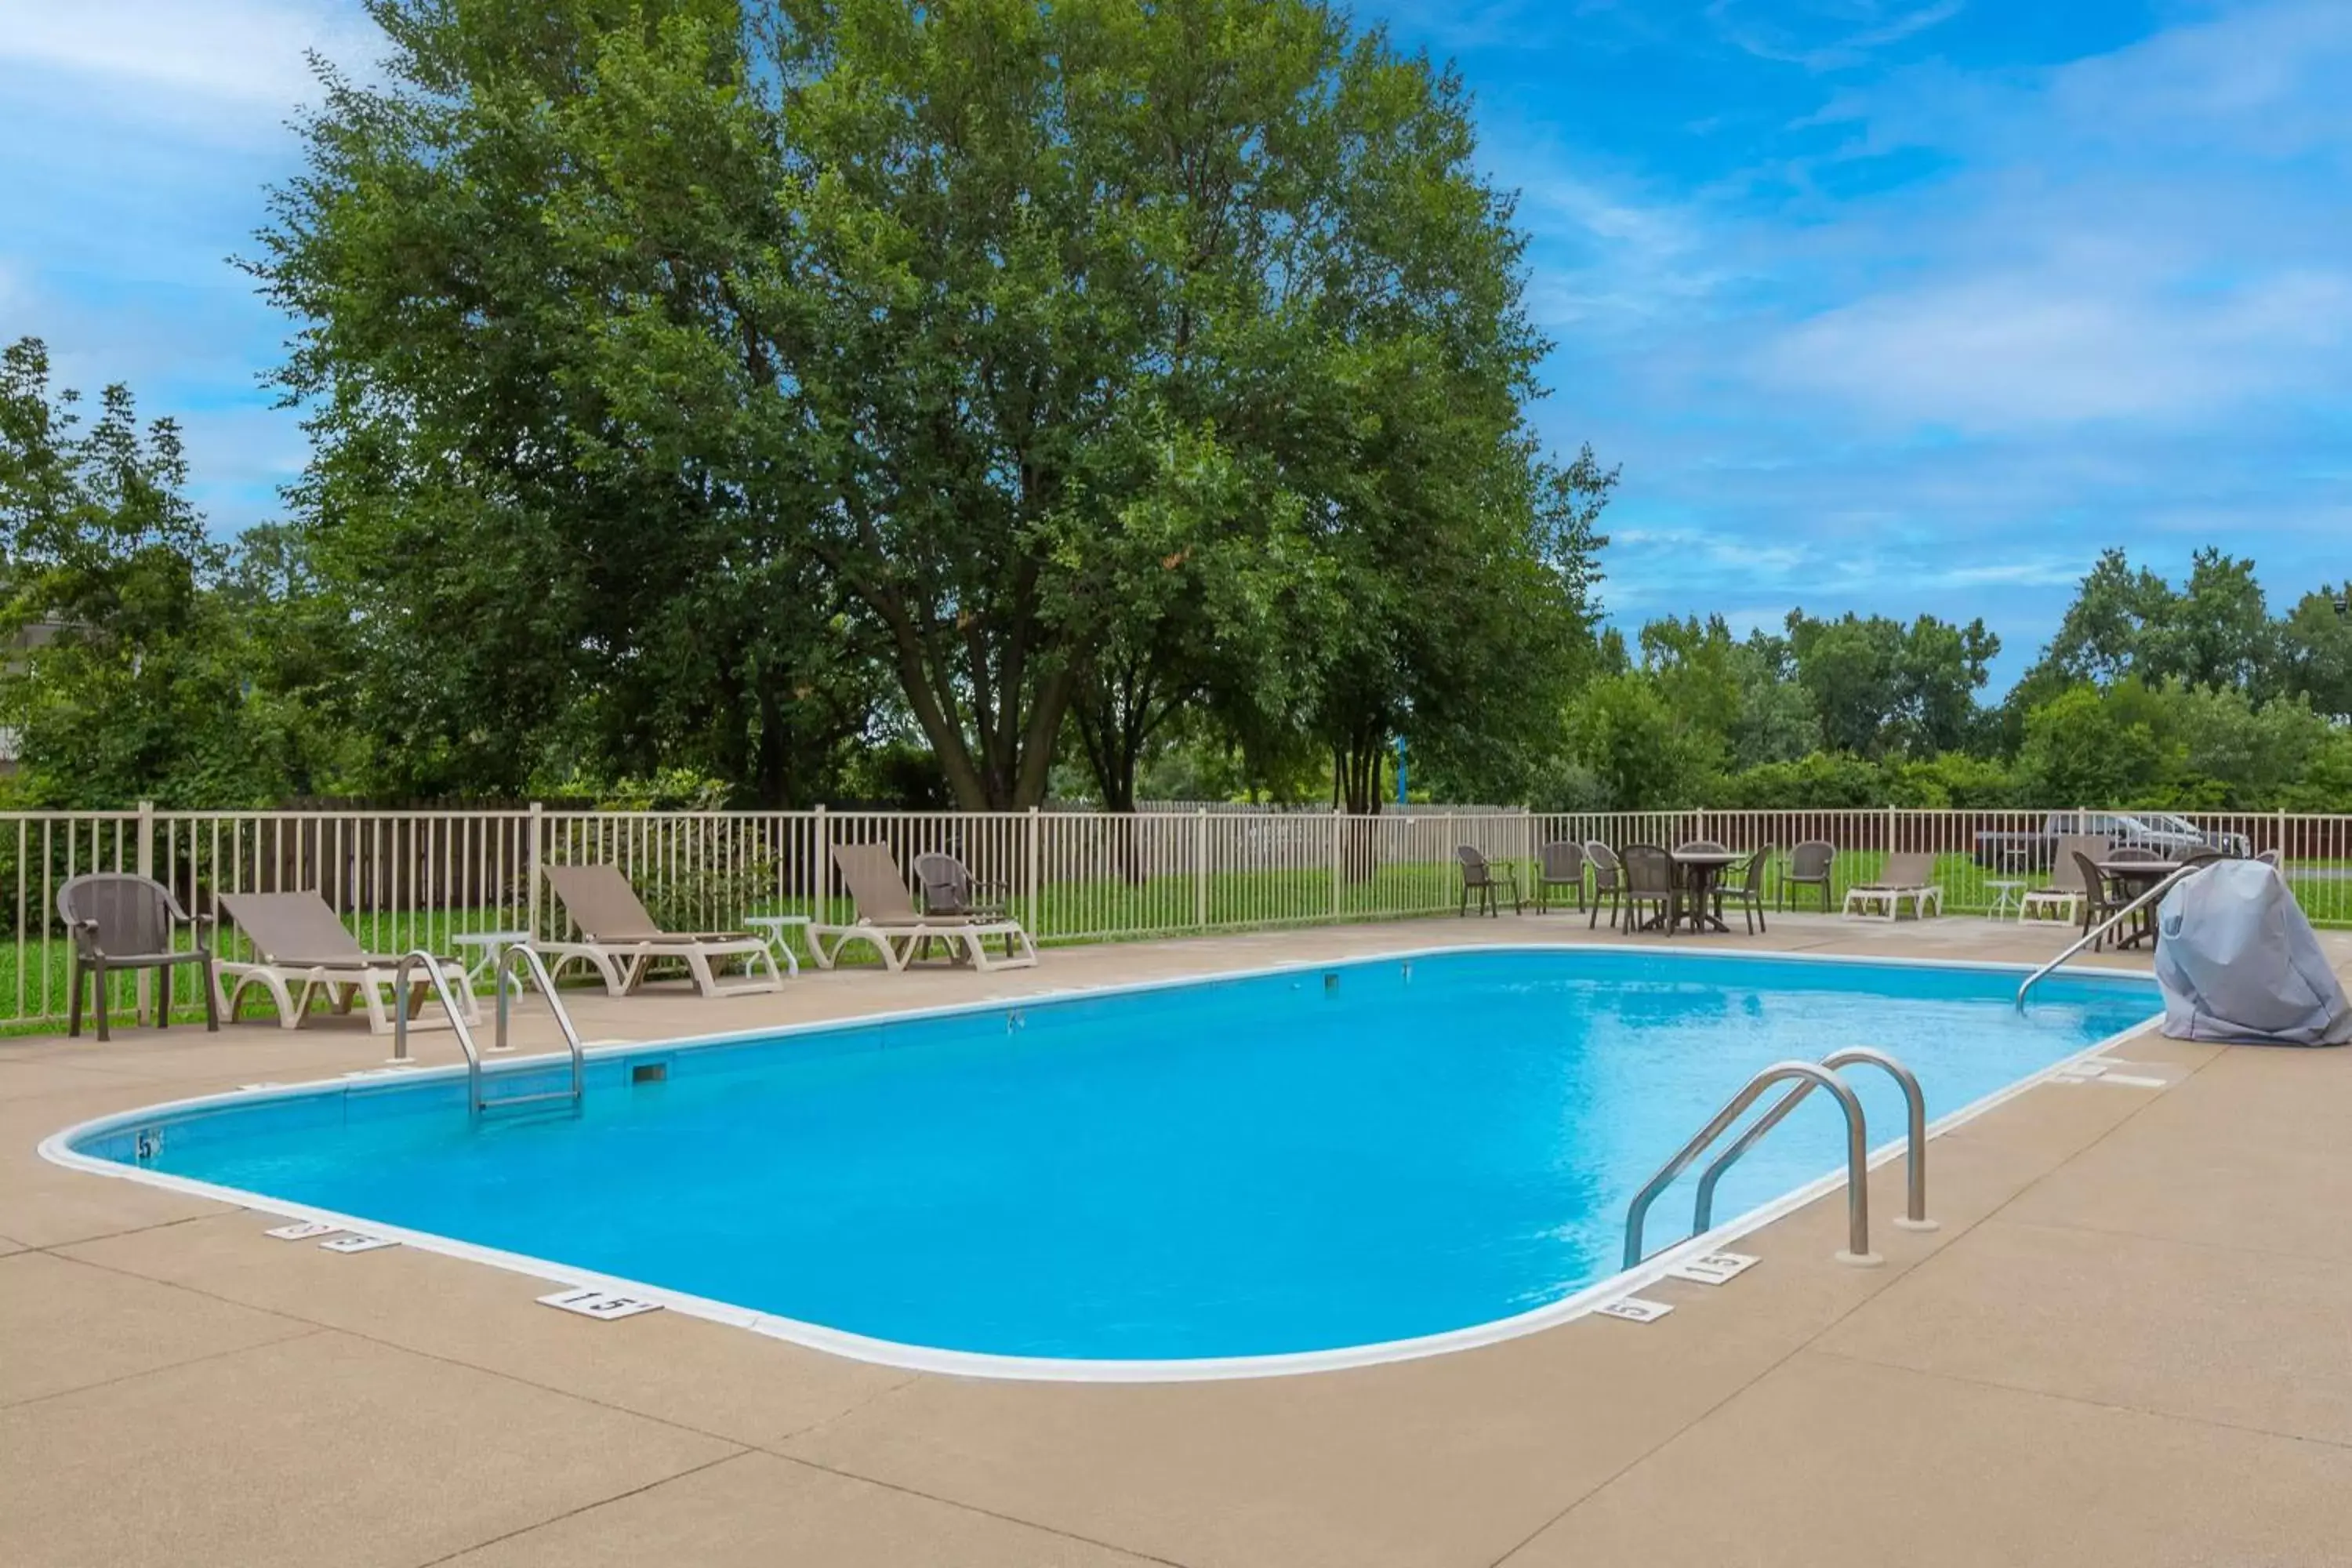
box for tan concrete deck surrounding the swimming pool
[0,914,2352,1568]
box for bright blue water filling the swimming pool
[80,949,2157,1359]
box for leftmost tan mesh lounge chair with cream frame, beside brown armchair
[214,893,482,1034]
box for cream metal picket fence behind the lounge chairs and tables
[0,806,2352,1027]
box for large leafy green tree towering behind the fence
[256,0,1576,808]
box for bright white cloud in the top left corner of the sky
[0,0,374,108]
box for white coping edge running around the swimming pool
[38,940,2161,1382]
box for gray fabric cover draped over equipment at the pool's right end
[2157,860,2352,1046]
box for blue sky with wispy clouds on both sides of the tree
[0,0,2352,684]
